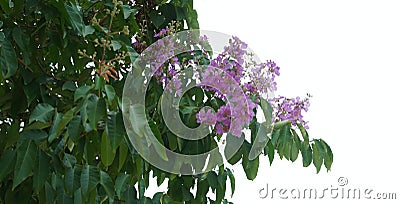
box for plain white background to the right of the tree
[194,0,400,204]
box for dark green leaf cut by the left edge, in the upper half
[0,40,18,78]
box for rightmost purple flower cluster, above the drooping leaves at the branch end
[270,96,310,129]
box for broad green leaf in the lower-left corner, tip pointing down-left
[12,140,36,190]
